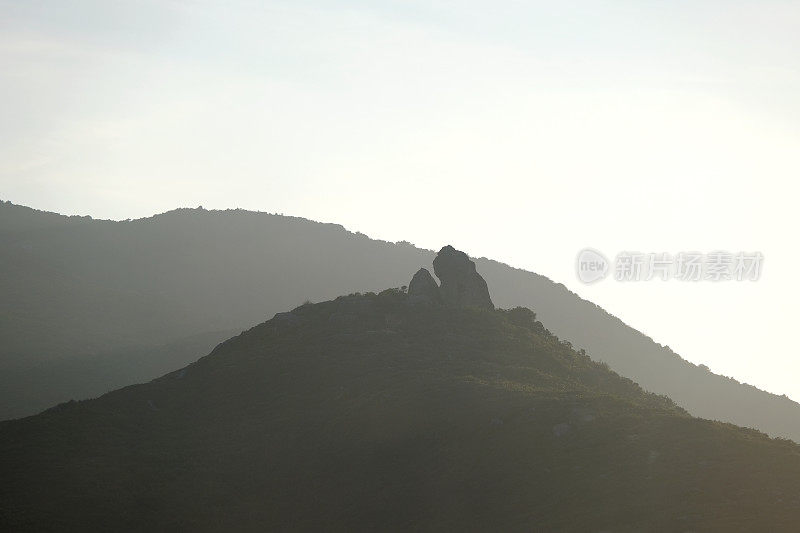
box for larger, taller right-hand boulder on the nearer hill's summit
[433,246,494,309]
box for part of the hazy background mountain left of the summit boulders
[0,202,428,419]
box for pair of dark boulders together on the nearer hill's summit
[408,245,494,309]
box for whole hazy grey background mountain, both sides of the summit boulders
[0,202,800,441]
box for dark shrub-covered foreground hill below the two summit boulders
[0,289,800,531]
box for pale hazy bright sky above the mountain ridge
[0,0,800,400]
